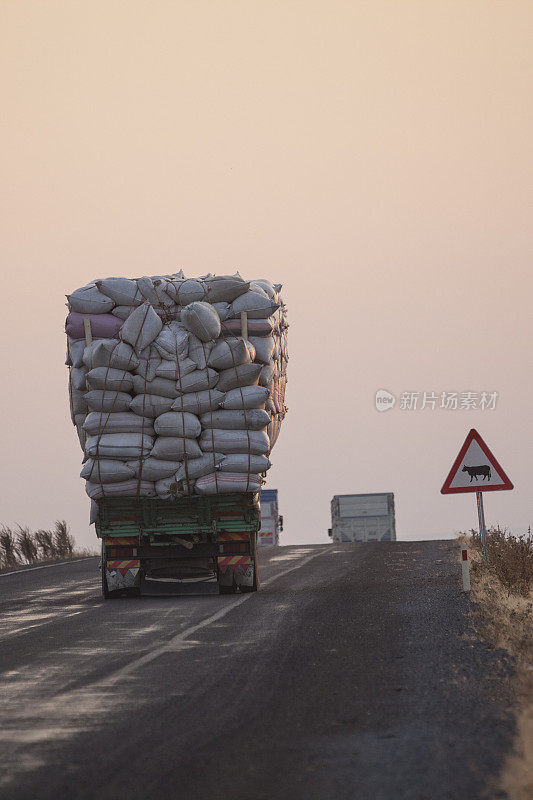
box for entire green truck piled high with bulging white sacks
[66,271,288,598]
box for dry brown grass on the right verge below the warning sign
[462,527,533,800]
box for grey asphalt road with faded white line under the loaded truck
[0,542,513,800]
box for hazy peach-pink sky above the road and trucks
[0,0,533,545]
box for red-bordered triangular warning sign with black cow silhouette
[441,428,514,494]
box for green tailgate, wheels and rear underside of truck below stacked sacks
[96,493,261,599]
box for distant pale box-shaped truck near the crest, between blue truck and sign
[328,492,396,542]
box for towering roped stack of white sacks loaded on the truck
[66,272,288,500]
